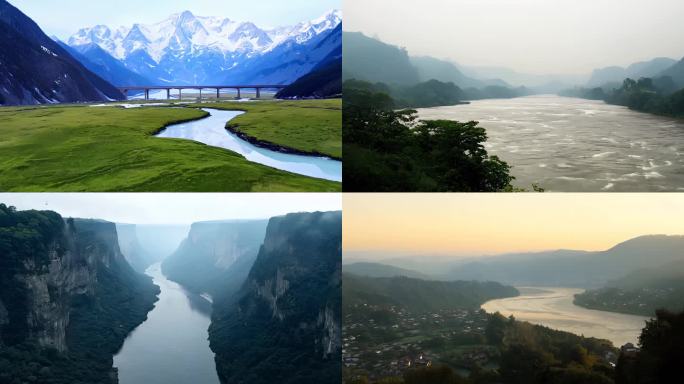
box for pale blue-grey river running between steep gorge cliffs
[114,264,219,384]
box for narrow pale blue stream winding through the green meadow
[157,108,342,181]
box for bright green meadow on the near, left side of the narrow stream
[0,101,341,192]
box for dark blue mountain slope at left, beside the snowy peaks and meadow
[0,0,123,105]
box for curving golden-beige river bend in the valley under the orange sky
[482,287,648,347]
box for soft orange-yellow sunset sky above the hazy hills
[343,193,684,257]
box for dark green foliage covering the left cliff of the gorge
[0,204,158,384]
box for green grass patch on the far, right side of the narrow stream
[198,99,342,159]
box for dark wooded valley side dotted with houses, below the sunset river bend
[343,277,618,384]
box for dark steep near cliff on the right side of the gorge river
[209,212,342,383]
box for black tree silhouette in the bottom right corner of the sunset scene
[615,310,684,384]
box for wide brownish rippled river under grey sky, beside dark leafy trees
[418,95,684,192]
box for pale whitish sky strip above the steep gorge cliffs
[0,193,342,224]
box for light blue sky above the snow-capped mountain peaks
[8,0,342,39]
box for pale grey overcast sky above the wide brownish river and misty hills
[344,0,684,74]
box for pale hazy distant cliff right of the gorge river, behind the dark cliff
[162,220,268,296]
